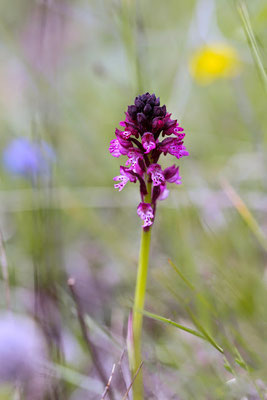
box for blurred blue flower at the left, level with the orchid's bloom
[3,138,55,178]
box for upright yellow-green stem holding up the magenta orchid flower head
[131,184,151,400]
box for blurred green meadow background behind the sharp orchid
[0,0,267,400]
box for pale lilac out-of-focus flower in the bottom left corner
[0,313,48,400]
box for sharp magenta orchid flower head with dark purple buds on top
[109,93,189,229]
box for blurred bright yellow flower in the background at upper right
[189,43,240,85]
